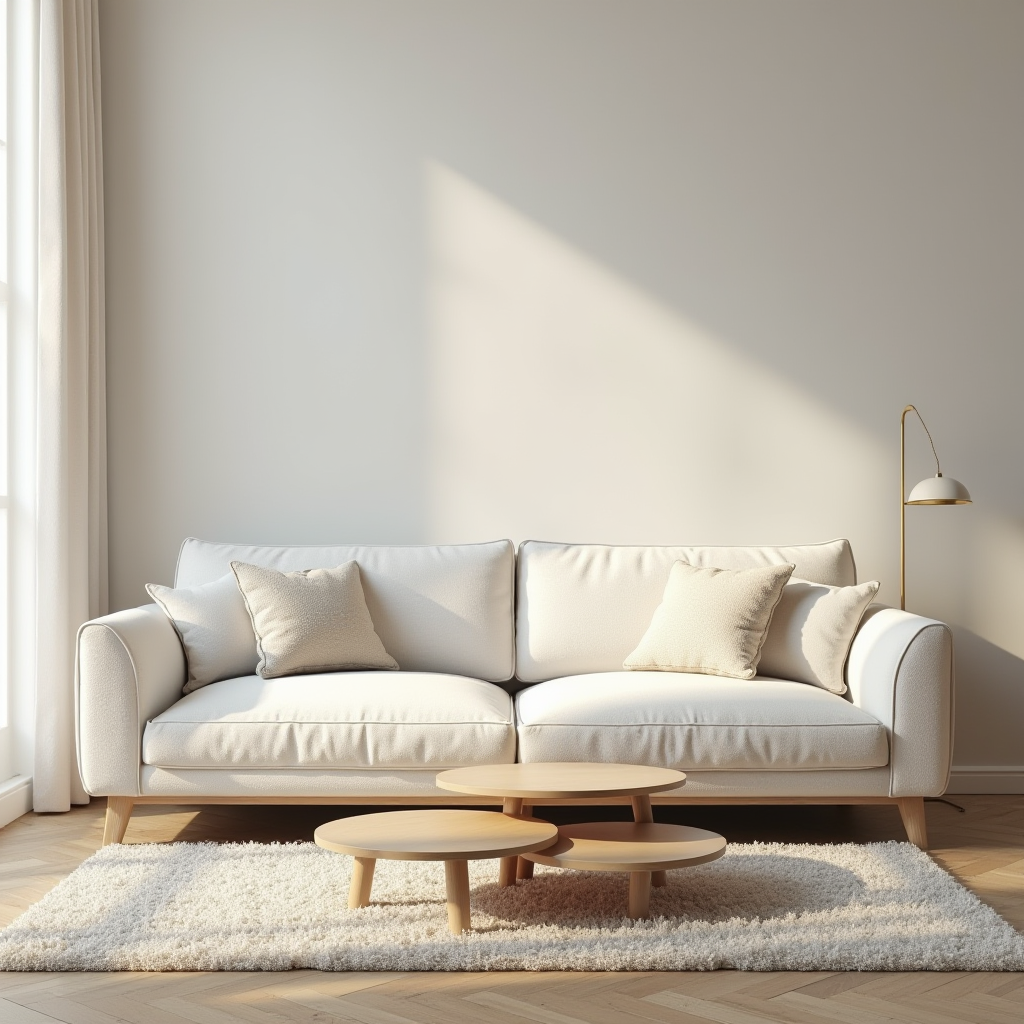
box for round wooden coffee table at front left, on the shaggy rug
[313,808,558,935]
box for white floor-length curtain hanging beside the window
[33,0,108,811]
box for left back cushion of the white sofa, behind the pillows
[174,538,515,683]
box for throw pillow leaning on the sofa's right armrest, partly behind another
[758,579,879,693]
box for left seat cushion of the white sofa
[142,672,516,771]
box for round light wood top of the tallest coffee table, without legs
[435,761,686,800]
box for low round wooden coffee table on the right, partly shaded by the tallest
[522,821,726,919]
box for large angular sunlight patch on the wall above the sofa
[426,163,892,561]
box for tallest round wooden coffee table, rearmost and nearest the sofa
[435,761,686,886]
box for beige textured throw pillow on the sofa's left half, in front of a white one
[231,562,398,679]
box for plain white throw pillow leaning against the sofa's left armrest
[145,572,258,693]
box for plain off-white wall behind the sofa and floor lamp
[100,0,1024,788]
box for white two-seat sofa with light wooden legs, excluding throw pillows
[76,540,952,847]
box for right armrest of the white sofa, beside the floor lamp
[847,604,953,797]
